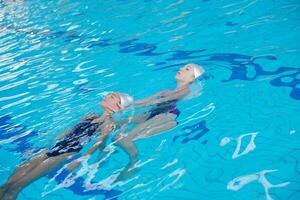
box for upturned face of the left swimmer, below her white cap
[100,92,122,113]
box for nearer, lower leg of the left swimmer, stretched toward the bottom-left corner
[3,152,75,200]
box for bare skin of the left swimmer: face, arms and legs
[0,93,122,200]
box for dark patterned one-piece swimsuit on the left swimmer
[46,116,101,157]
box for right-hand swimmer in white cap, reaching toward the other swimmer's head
[114,64,204,180]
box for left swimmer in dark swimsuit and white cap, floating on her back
[0,93,132,200]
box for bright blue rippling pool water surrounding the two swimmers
[0,0,300,200]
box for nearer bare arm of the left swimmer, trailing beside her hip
[67,121,114,171]
